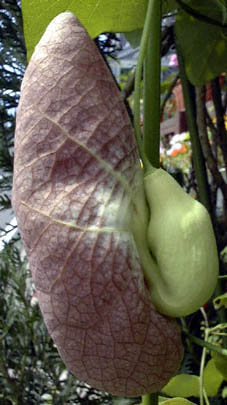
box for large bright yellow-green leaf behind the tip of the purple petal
[22,0,148,59]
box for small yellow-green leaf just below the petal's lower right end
[162,374,199,398]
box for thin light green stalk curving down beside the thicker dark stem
[134,0,161,171]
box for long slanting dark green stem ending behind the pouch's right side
[175,34,211,213]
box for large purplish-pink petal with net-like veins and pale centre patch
[13,12,182,396]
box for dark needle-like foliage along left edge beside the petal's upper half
[0,0,26,210]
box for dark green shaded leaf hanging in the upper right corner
[175,0,227,86]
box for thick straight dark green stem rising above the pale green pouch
[143,0,162,168]
